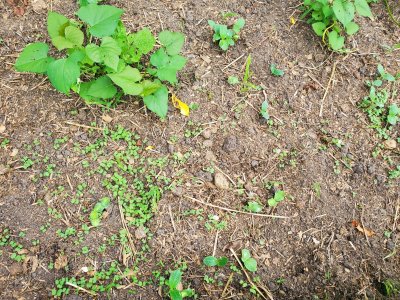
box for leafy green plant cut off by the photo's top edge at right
[301,0,373,51]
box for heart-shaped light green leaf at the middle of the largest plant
[86,37,121,71]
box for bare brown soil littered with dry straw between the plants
[0,0,400,299]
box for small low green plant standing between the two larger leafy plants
[208,18,246,51]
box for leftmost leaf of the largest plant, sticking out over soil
[15,43,54,73]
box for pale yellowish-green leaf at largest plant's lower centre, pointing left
[107,66,143,96]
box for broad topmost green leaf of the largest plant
[78,4,124,37]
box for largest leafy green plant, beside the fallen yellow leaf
[15,0,186,118]
